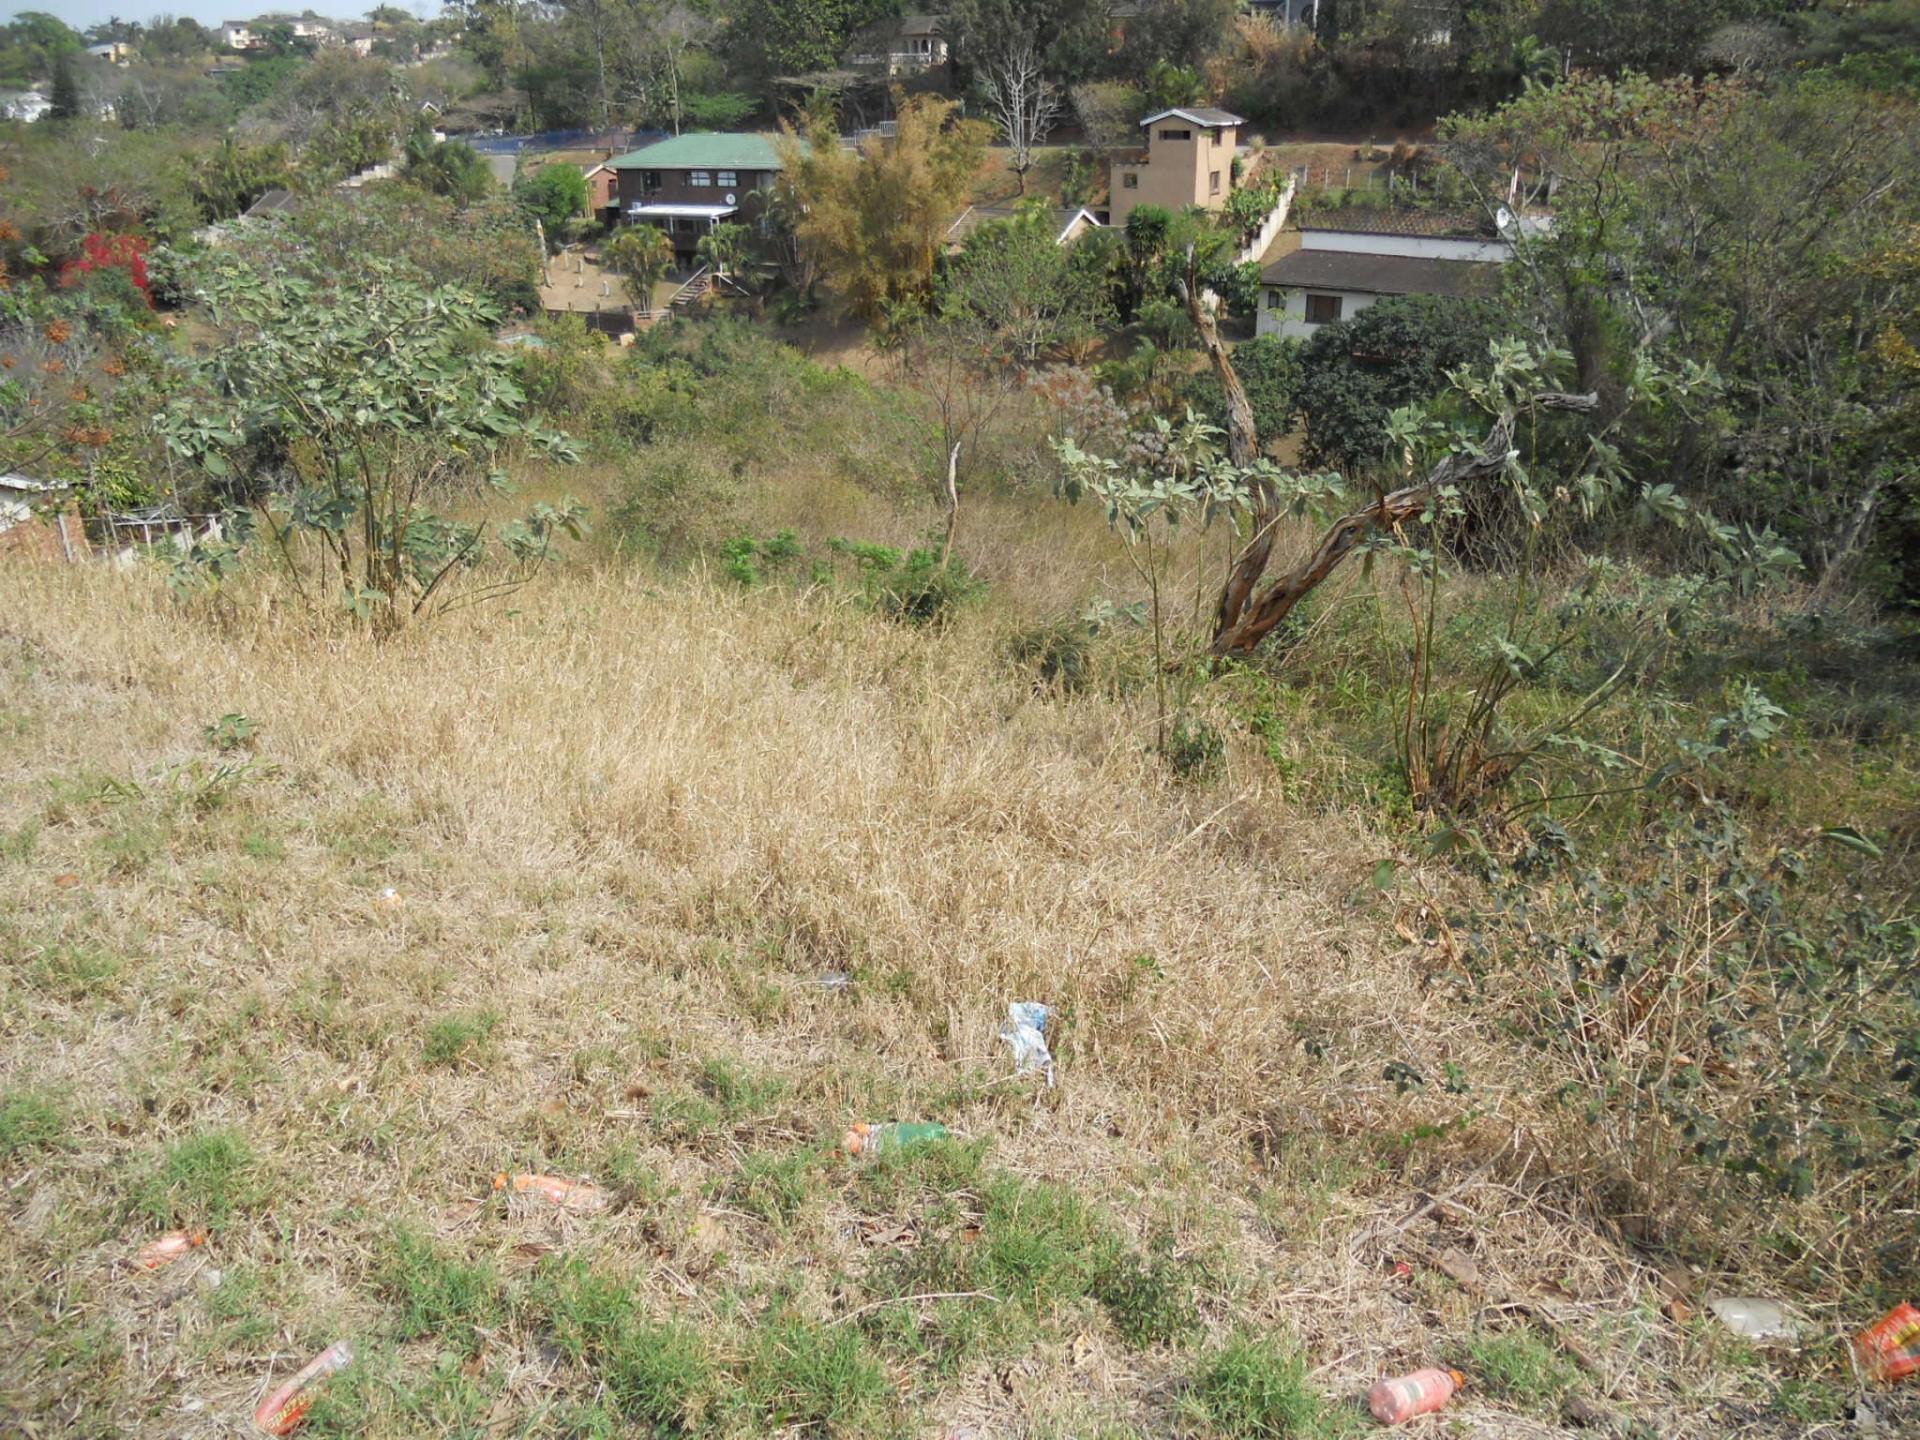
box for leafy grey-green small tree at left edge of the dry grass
[156,255,582,634]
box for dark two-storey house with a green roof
[607,132,780,263]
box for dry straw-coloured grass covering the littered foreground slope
[0,545,1896,1436]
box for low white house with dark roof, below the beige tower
[1258,209,1538,338]
